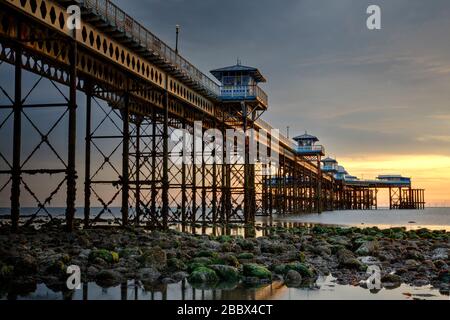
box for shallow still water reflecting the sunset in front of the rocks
[0,276,449,300]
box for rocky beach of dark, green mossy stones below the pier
[0,220,450,295]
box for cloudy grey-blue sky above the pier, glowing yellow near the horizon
[0,0,450,205]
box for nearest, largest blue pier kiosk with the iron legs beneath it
[211,61,268,223]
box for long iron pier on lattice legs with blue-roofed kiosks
[0,0,425,231]
